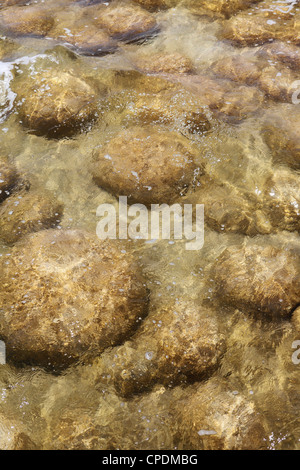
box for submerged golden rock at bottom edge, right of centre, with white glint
[174,379,268,450]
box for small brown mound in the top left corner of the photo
[0,5,54,36]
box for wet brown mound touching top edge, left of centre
[88,2,158,42]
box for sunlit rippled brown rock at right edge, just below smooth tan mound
[264,168,300,232]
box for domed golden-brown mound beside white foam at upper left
[18,71,97,137]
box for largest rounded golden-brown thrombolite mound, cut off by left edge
[0,230,147,366]
